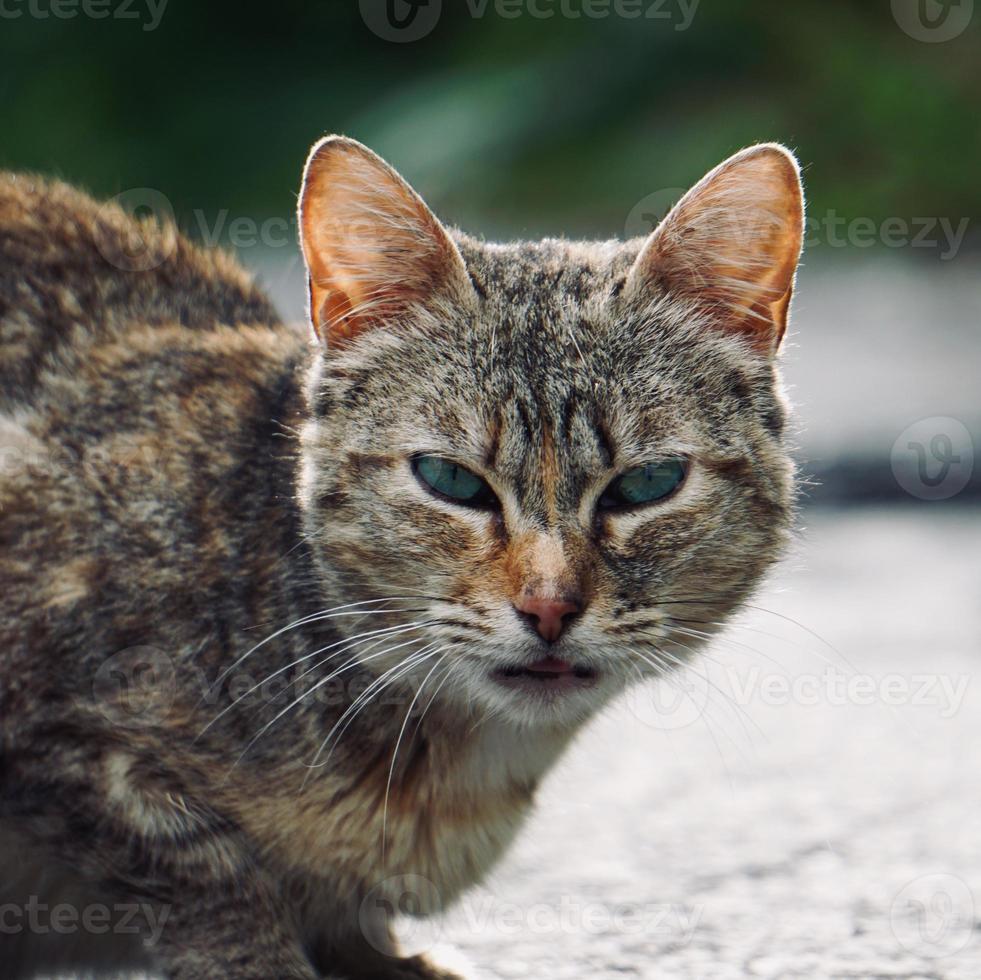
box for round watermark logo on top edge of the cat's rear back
[95,187,177,272]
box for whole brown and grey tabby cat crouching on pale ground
[0,136,803,980]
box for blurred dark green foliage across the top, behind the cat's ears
[0,0,981,236]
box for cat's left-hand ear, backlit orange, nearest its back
[299,136,474,346]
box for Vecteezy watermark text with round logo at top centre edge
[360,0,700,44]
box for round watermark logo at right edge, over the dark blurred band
[891,416,974,500]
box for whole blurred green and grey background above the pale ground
[0,0,981,501]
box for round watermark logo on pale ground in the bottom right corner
[889,874,974,959]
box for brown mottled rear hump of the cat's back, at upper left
[0,173,277,412]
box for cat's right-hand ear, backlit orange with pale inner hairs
[624,143,804,355]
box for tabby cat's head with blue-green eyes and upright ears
[300,137,803,725]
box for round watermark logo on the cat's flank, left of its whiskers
[92,646,177,728]
